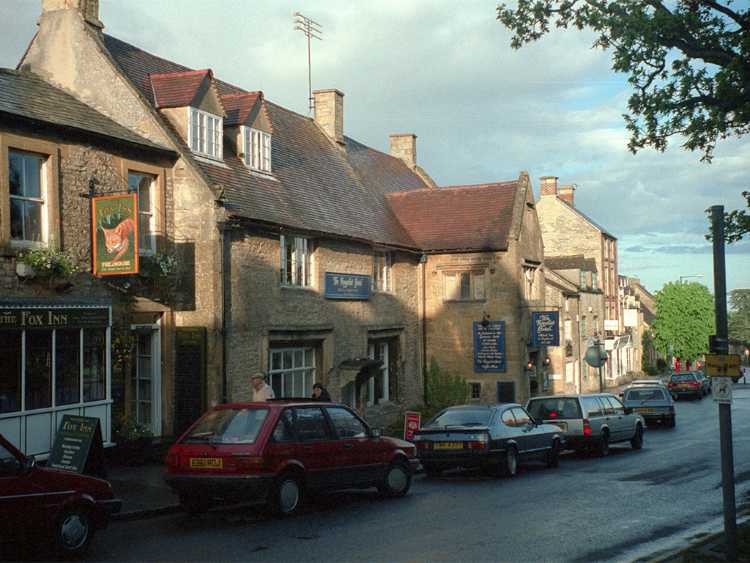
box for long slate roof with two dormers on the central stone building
[102,34,426,248]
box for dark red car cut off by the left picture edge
[0,435,122,556]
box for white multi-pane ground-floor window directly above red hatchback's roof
[268,347,316,398]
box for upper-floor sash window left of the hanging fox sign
[8,150,47,243]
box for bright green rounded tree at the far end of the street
[653,282,715,360]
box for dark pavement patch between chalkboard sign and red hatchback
[107,464,179,520]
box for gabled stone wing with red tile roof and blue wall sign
[388,178,546,402]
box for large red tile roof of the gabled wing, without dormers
[386,180,518,251]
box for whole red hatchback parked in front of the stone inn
[165,399,419,515]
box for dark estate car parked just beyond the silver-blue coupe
[526,393,646,456]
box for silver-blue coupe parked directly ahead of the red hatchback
[414,403,564,477]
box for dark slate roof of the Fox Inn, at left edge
[0,68,173,153]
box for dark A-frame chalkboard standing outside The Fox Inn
[47,414,103,473]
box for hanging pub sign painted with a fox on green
[91,193,138,276]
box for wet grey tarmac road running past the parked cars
[76,386,750,562]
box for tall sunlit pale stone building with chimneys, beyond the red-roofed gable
[536,176,626,386]
